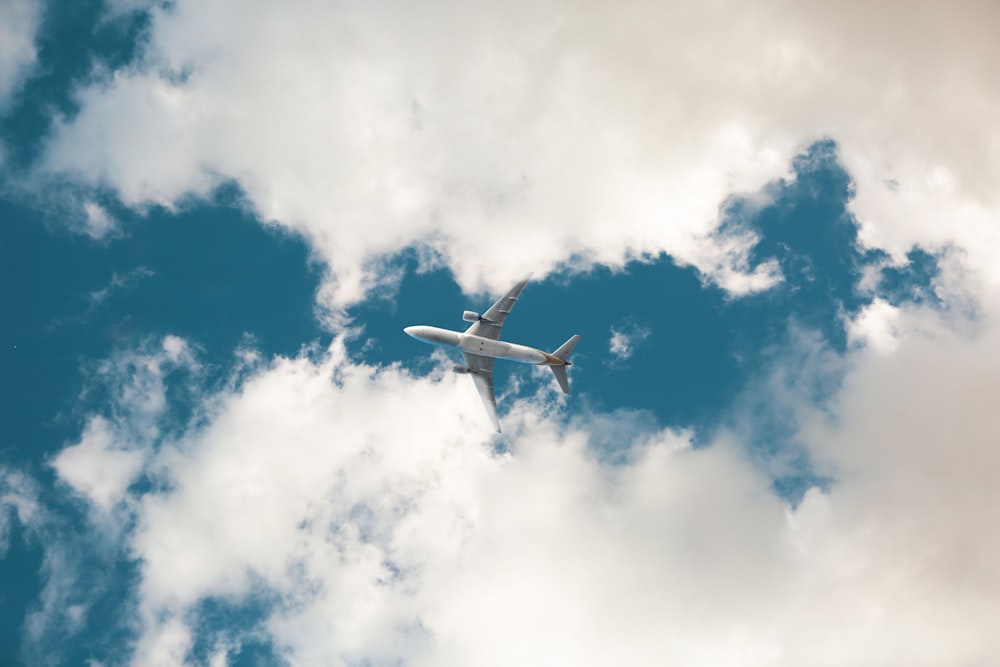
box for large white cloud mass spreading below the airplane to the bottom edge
[25,305,1000,665]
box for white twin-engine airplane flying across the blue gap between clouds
[403,276,580,433]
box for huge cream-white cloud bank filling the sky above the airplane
[35,0,1000,304]
